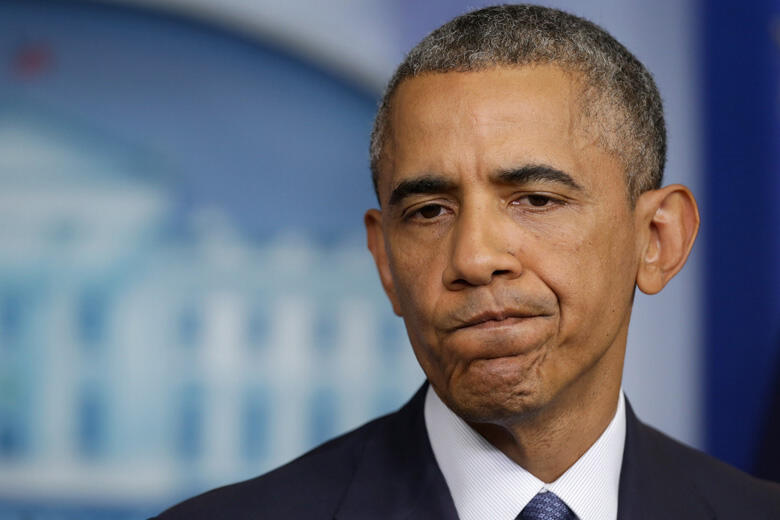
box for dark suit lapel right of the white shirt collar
[618,401,715,520]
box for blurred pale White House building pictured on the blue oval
[0,109,422,500]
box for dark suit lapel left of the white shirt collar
[335,384,457,520]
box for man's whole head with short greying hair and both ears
[365,6,698,423]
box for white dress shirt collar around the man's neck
[425,386,626,520]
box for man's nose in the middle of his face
[443,205,523,291]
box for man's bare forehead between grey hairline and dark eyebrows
[379,65,620,201]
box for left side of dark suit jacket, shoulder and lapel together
[152,385,432,520]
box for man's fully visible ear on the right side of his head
[634,184,699,294]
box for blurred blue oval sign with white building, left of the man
[0,0,422,518]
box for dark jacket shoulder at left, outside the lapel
[157,414,393,520]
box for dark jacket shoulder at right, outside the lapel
[640,418,780,518]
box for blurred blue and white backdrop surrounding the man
[0,0,780,519]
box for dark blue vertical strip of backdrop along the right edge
[701,0,780,470]
